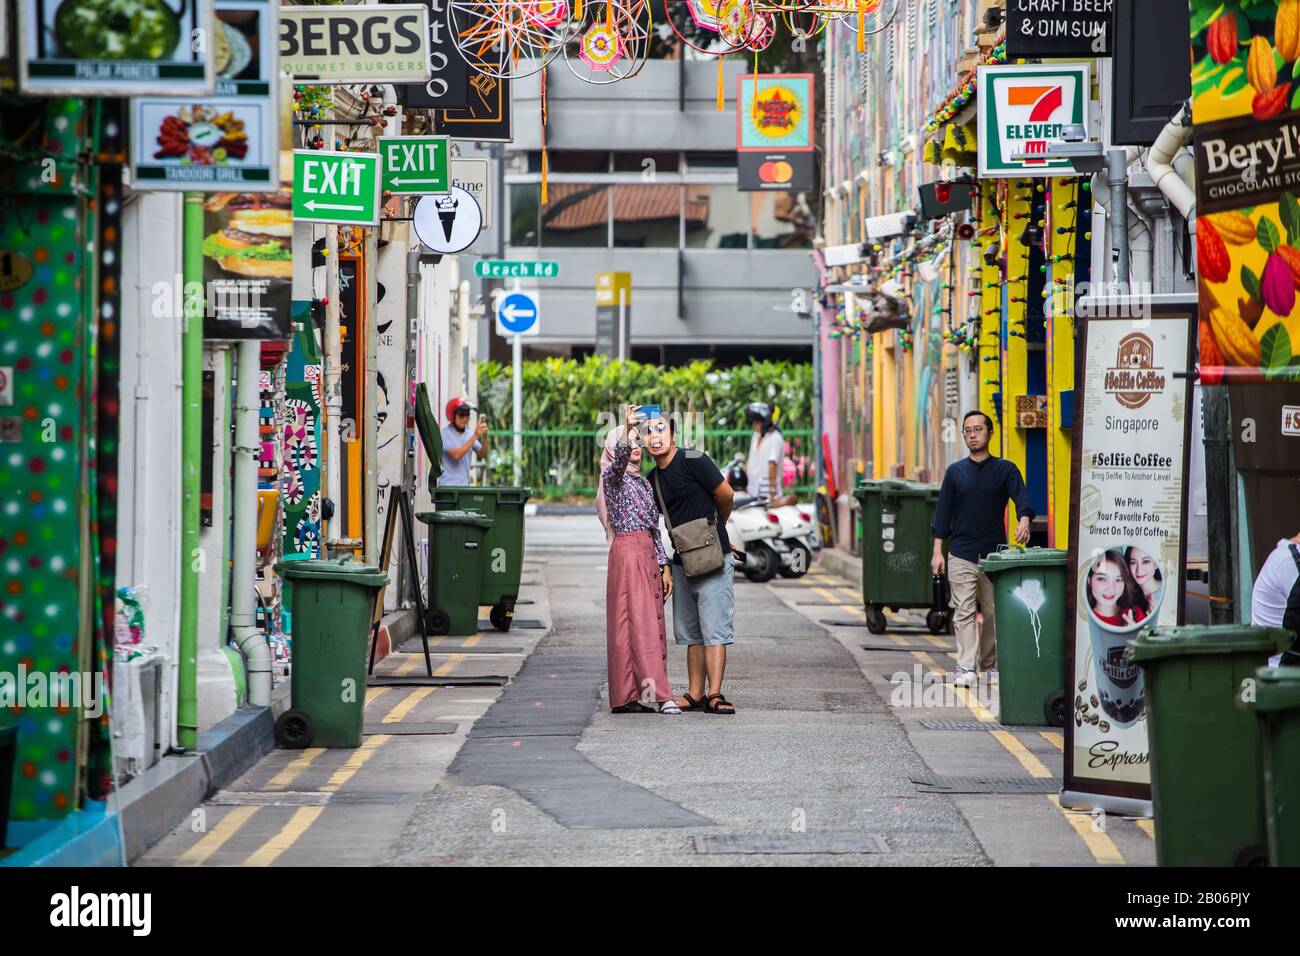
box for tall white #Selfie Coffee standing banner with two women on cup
[1065,306,1192,806]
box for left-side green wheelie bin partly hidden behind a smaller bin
[430,485,533,631]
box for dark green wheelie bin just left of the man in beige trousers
[853,479,952,633]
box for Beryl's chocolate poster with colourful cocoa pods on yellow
[1191,0,1300,382]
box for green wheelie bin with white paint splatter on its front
[980,548,1069,727]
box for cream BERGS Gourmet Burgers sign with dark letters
[280,4,429,83]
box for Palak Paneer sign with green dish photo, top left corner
[17,0,215,96]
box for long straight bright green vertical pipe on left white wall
[176,193,205,750]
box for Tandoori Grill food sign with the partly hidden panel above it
[131,0,280,193]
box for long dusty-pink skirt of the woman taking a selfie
[605,531,672,708]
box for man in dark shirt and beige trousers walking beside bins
[931,411,1034,687]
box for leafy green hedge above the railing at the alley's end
[478,356,813,433]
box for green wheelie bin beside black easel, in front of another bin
[416,511,493,635]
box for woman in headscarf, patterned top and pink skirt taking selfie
[601,406,681,714]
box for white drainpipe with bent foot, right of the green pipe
[230,339,270,708]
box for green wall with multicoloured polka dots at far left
[0,100,88,819]
